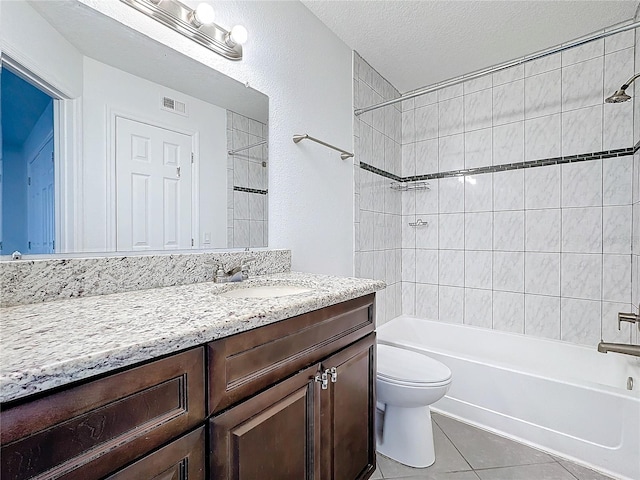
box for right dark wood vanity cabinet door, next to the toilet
[320,333,376,480]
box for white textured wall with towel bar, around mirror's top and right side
[80,0,353,275]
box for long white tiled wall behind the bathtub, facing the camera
[359,24,640,345]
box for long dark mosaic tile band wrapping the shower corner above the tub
[360,146,640,182]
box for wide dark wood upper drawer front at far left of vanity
[0,348,205,480]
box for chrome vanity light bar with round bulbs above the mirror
[120,0,248,60]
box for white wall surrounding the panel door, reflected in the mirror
[80,57,227,252]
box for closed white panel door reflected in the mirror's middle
[116,117,193,251]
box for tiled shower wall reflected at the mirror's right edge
[227,110,268,248]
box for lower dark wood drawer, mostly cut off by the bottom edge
[105,427,205,480]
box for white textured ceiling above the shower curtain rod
[302,0,638,93]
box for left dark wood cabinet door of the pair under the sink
[210,366,320,480]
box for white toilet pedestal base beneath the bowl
[377,405,436,468]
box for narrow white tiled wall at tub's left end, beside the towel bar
[353,52,402,324]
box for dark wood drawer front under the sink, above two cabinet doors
[208,294,375,413]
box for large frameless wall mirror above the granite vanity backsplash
[0,0,269,255]
